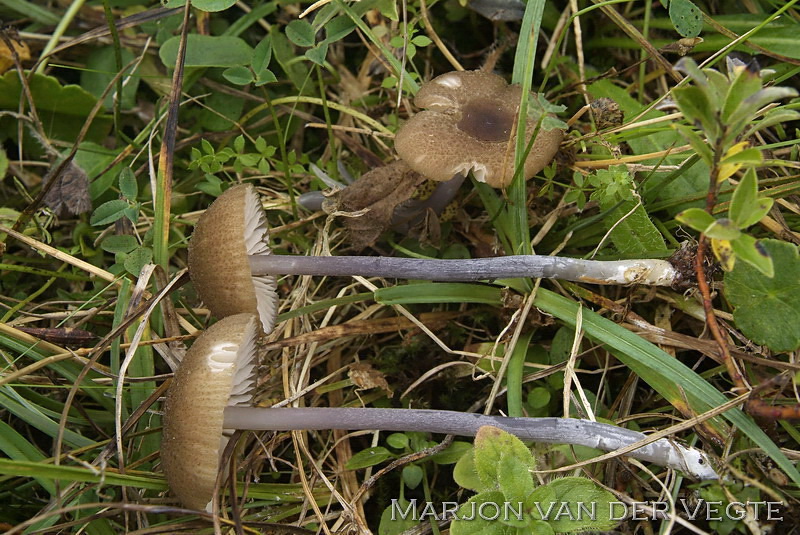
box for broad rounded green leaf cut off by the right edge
[725,240,800,351]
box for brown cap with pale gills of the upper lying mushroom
[189,184,278,333]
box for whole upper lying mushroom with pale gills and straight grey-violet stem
[189,184,680,333]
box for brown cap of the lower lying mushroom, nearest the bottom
[161,314,260,510]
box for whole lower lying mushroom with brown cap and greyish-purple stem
[161,314,718,511]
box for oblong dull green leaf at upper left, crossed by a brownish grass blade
[158,33,253,69]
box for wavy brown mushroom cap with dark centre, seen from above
[395,71,564,188]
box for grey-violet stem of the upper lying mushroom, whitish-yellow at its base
[249,254,678,286]
